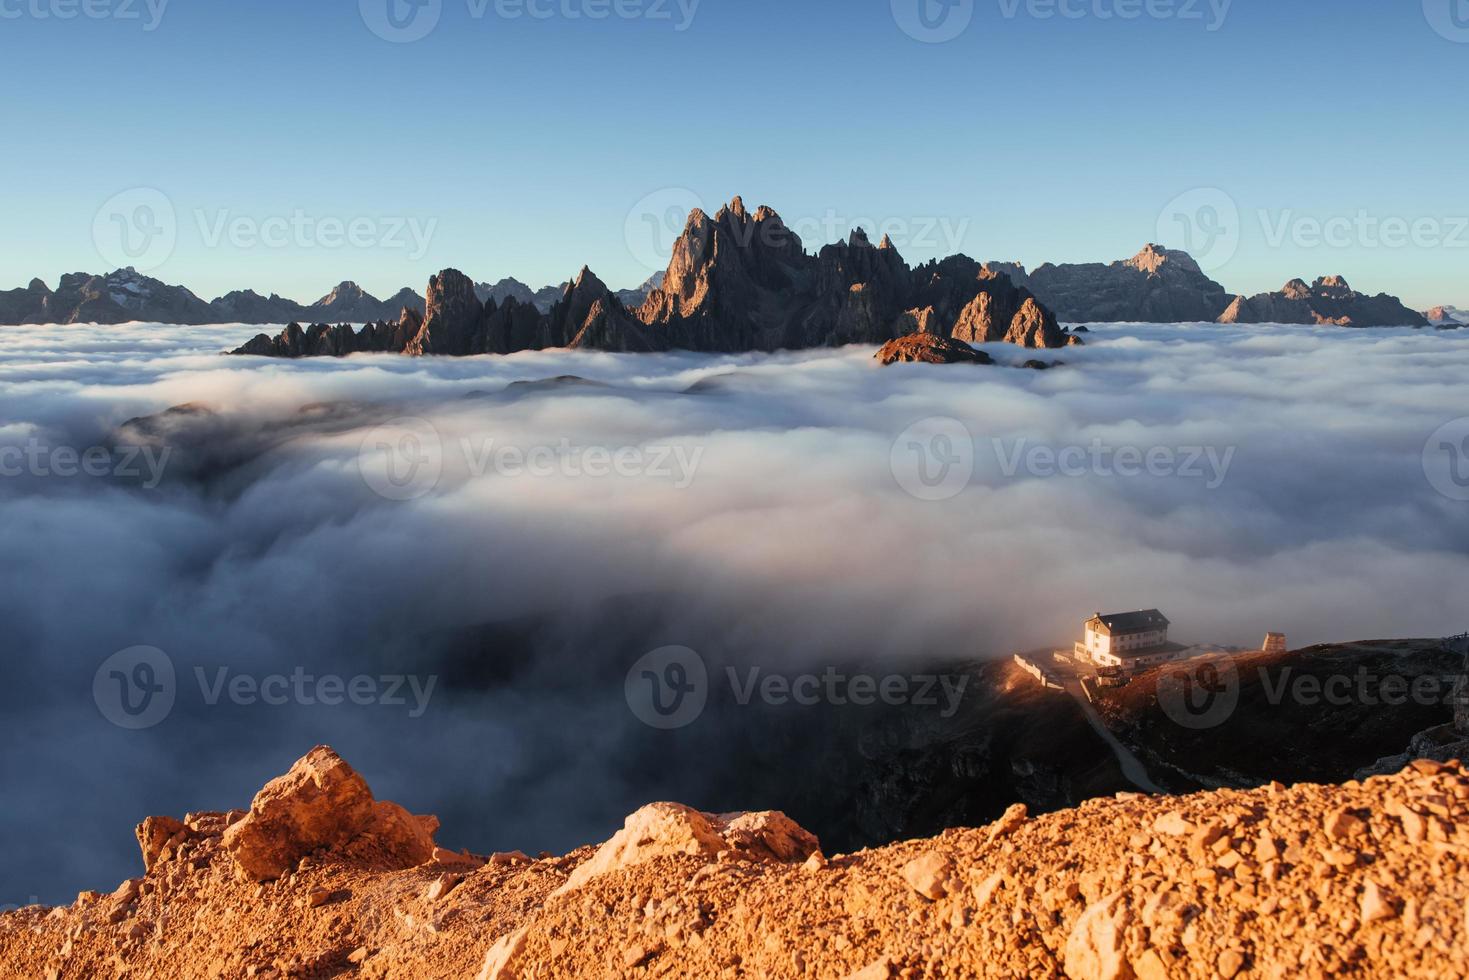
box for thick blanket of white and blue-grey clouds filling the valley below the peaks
[0,325,1469,904]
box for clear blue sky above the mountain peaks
[0,0,1469,307]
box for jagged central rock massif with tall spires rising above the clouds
[235,197,1080,357]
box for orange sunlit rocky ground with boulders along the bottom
[0,748,1469,980]
